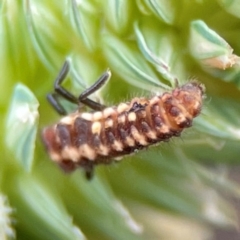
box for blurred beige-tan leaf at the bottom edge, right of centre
[128,201,212,240]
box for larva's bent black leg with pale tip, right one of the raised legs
[78,70,111,110]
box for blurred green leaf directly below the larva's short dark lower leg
[64,173,143,240]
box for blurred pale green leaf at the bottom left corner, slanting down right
[15,177,86,240]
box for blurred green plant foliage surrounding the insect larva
[0,0,240,240]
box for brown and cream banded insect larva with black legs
[42,61,205,179]
